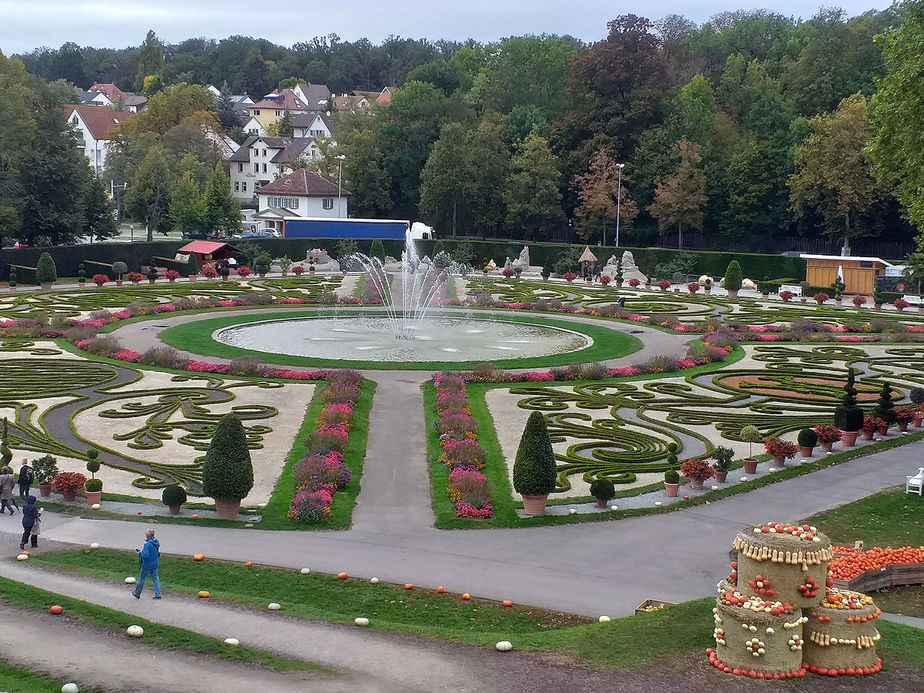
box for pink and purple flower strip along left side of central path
[288,371,363,522]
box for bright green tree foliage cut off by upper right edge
[872,2,924,241]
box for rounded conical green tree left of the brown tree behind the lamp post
[504,132,565,240]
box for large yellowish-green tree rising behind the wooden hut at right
[789,94,880,248]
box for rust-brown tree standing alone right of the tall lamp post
[648,139,708,248]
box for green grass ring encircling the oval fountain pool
[160,311,642,370]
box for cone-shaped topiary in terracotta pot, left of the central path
[202,414,253,520]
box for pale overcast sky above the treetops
[0,0,890,55]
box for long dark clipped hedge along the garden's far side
[0,238,805,281]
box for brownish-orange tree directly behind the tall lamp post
[574,149,638,243]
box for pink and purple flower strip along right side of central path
[433,373,494,519]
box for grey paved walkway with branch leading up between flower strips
[9,438,924,616]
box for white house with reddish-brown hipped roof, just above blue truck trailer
[254,168,351,231]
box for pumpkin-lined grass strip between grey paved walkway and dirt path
[33,549,924,670]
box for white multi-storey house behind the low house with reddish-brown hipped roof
[228,135,321,203]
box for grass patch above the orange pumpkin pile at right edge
[808,487,924,548]
